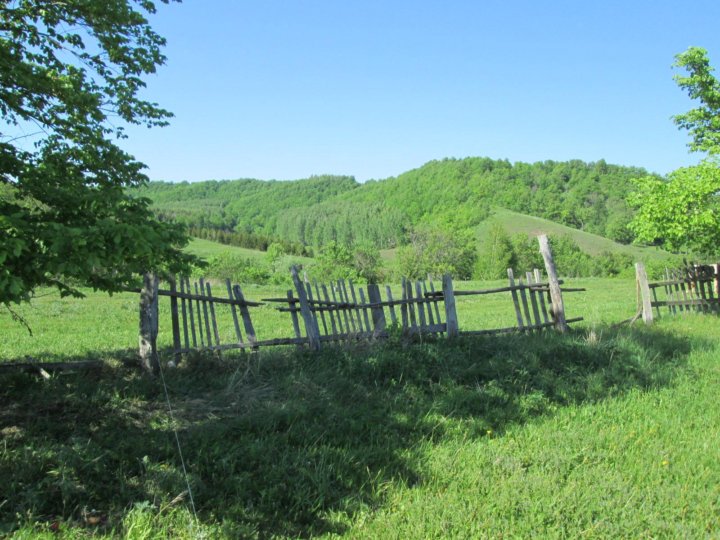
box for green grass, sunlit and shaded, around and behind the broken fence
[0,279,720,539]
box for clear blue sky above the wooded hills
[124,0,720,181]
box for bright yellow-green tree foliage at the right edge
[628,47,720,254]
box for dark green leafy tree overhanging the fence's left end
[0,0,192,305]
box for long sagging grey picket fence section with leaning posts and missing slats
[140,234,584,371]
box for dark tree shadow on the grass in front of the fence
[0,322,704,537]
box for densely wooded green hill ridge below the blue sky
[140,158,647,247]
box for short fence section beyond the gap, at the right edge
[635,263,720,324]
